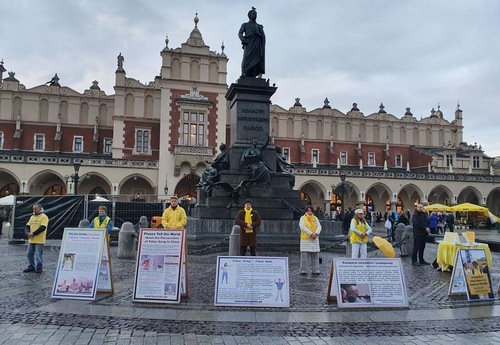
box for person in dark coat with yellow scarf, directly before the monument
[235,199,260,256]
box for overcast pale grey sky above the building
[0,0,500,156]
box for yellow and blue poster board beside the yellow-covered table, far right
[458,249,495,301]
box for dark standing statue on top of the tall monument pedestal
[238,7,266,78]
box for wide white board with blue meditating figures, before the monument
[214,256,290,308]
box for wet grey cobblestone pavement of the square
[0,226,500,344]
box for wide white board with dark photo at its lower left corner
[334,258,408,308]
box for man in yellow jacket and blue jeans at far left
[23,204,49,273]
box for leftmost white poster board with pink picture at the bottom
[52,228,106,300]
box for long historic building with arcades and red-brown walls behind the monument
[0,17,500,213]
